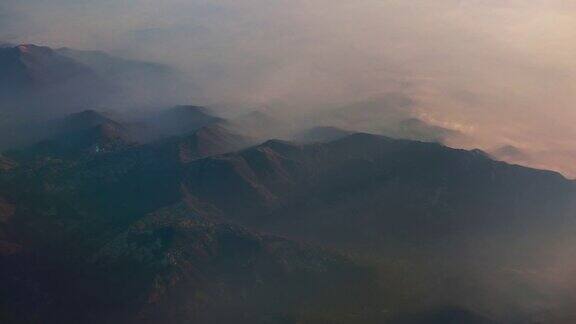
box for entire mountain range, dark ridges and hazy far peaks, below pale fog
[0,41,576,324]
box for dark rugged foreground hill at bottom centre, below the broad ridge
[76,208,382,323]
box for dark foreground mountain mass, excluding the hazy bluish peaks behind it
[0,128,576,323]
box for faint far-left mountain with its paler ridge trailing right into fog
[0,44,191,119]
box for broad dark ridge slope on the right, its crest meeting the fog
[187,134,576,251]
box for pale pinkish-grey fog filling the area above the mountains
[0,0,576,177]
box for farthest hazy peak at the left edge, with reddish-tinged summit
[0,45,115,118]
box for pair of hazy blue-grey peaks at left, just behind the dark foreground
[7,106,264,162]
